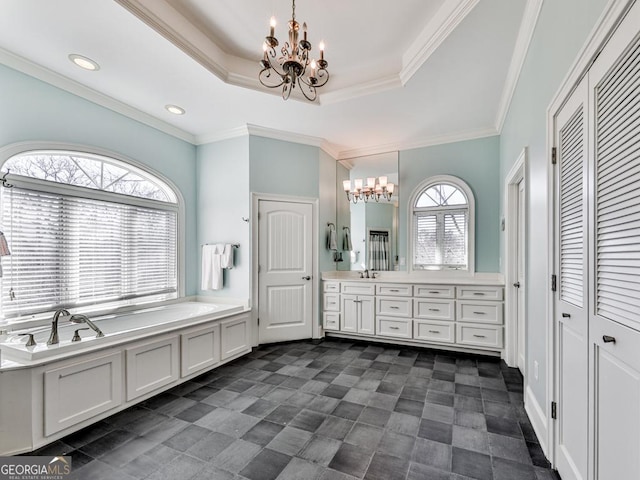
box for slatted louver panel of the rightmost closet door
[595,32,640,328]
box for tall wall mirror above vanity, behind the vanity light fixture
[335,152,398,271]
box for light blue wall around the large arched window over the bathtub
[0,65,196,295]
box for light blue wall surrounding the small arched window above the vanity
[398,136,500,272]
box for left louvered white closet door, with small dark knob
[554,74,589,480]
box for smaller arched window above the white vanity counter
[409,175,475,272]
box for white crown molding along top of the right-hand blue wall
[496,0,544,132]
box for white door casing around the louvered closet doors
[544,0,636,467]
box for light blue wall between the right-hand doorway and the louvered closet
[500,0,607,410]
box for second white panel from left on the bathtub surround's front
[125,335,179,401]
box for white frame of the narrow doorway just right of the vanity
[504,147,529,370]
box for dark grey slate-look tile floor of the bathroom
[31,340,559,480]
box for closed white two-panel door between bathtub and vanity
[258,200,313,343]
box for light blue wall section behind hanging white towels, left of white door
[197,136,251,302]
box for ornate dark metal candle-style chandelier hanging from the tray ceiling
[258,0,329,102]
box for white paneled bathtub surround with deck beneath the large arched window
[0,302,251,455]
